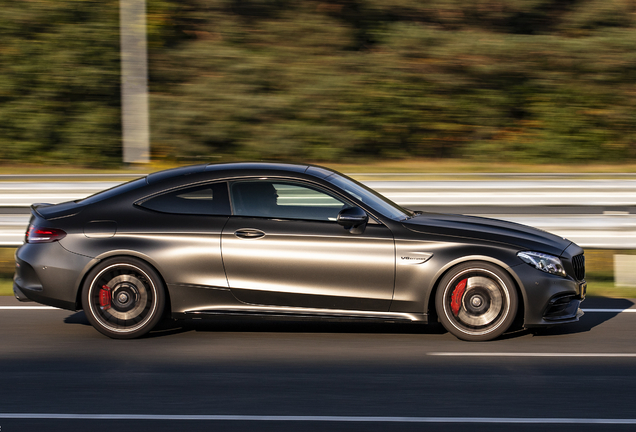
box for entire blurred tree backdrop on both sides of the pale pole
[0,0,636,166]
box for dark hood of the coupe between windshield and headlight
[403,213,572,256]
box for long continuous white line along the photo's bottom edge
[0,413,636,425]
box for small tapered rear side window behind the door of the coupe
[138,182,230,215]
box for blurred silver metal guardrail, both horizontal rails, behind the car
[0,178,636,249]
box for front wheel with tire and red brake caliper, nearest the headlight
[435,261,518,341]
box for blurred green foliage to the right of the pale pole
[152,0,636,163]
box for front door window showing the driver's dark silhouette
[230,180,349,222]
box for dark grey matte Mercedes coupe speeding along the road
[13,163,586,341]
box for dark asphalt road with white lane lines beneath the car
[0,297,636,432]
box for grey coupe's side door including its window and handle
[221,179,395,311]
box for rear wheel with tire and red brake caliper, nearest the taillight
[82,257,165,339]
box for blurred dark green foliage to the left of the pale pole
[0,0,174,166]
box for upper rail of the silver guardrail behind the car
[0,180,636,207]
